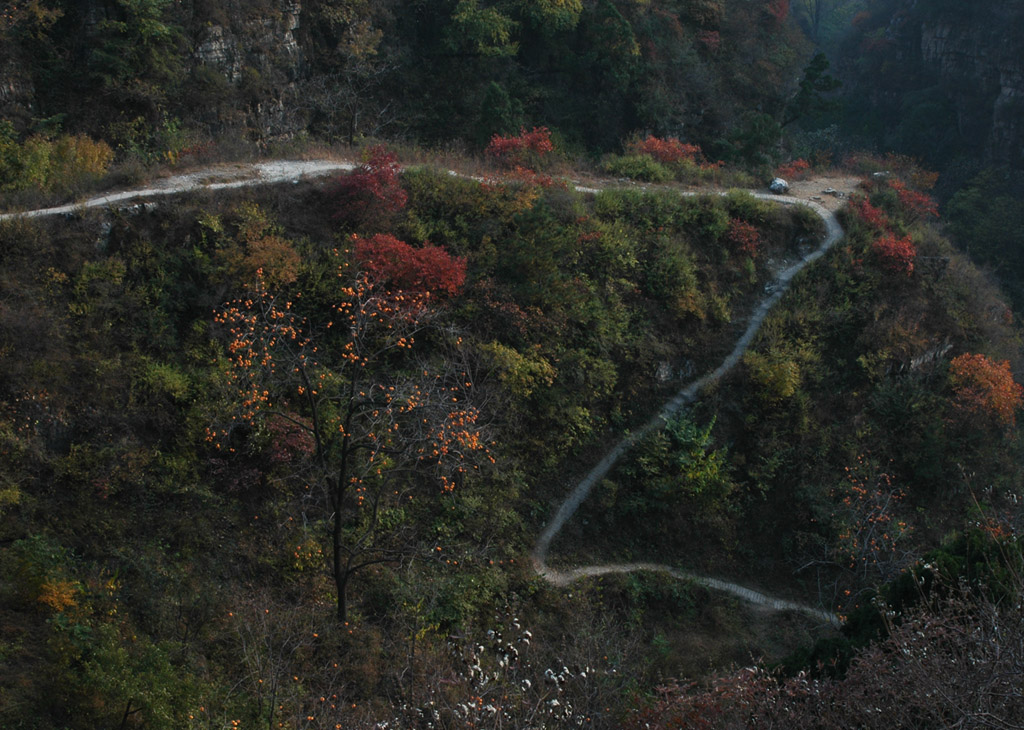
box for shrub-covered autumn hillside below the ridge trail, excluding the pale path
[0,152,1020,728]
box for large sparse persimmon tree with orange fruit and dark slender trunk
[208,237,486,621]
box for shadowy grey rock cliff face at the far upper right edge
[920,6,1024,167]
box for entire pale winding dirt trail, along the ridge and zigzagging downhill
[0,160,856,626]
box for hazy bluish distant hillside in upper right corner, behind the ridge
[844,0,1024,169]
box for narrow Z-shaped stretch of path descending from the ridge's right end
[532,190,843,626]
